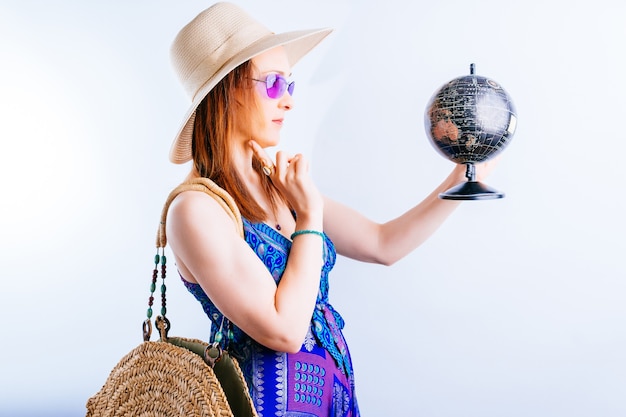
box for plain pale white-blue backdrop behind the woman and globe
[0,0,626,417]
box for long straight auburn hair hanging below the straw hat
[191,61,285,223]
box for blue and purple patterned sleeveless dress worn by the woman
[183,219,360,417]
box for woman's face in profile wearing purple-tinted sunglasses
[244,46,293,148]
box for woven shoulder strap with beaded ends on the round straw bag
[143,177,244,341]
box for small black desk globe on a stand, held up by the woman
[424,64,517,200]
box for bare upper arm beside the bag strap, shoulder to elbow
[166,191,280,343]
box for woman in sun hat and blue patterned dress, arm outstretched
[167,3,492,417]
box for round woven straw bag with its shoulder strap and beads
[87,178,257,417]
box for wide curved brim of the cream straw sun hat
[169,28,332,164]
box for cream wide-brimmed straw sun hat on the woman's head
[170,2,332,164]
